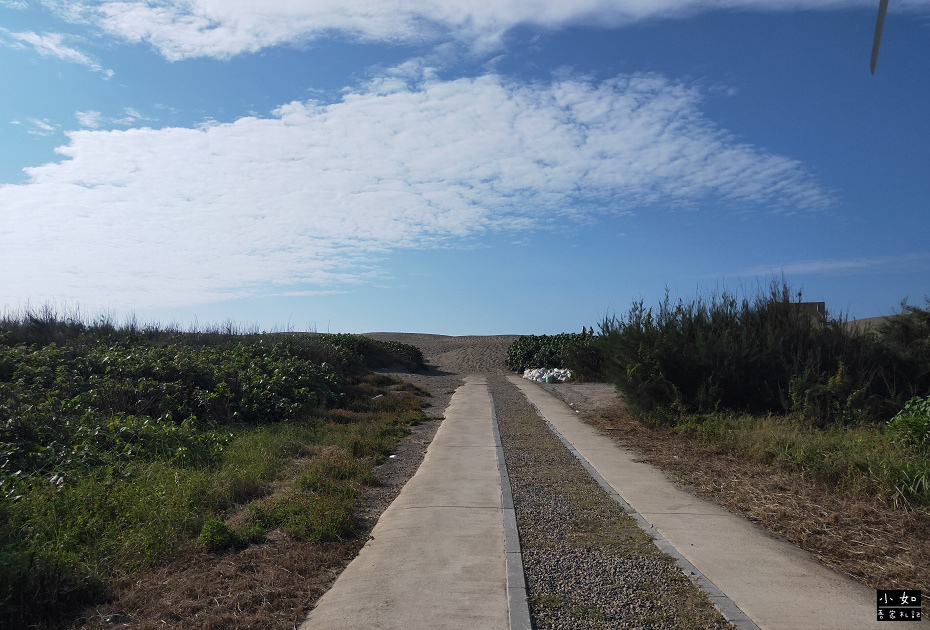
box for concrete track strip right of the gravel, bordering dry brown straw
[510,376,926,630]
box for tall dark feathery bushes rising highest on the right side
[600,282,930,426]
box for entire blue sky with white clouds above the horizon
[0,0,930,335]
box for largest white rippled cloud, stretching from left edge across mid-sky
[0,73,831,308]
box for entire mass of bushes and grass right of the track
[508,281,930,507]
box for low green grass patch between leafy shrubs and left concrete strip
[0,410,422,627]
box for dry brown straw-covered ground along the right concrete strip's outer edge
[585,403,930,610]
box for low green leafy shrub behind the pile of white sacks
[507,333,603,380]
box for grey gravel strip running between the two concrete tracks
[488,376,732,630]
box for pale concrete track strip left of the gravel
[301,376,510,630]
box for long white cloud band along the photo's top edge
[47,0,930,60]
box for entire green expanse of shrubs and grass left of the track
[0,310,423,627]
